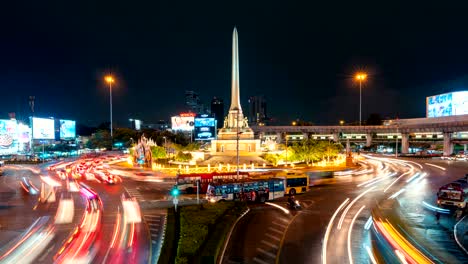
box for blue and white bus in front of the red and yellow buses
[206,178,285,203]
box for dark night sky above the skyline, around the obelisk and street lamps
[0,0,468,125]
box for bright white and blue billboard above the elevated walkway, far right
[426,91,468,117]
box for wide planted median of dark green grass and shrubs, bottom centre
[175,202,245,264]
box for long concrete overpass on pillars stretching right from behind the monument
[252,115,468,155]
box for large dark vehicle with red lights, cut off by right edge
[437,174,468,209]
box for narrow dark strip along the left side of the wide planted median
[158,208,179,264]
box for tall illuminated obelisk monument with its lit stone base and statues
[211,28,260,155]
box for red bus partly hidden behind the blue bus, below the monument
[176,171,249,193]
